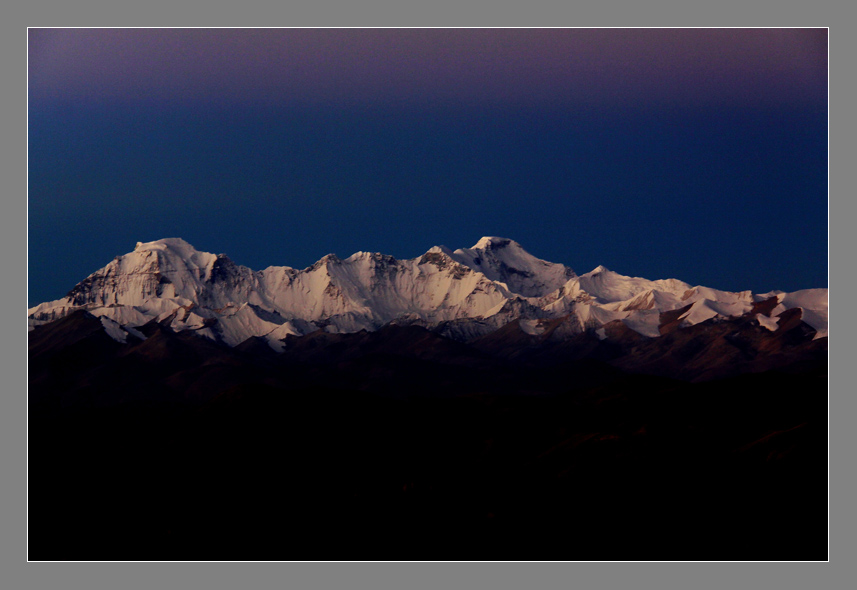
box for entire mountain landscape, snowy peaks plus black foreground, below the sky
[27,240,828,561]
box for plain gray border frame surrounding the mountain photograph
[11,0,844,590]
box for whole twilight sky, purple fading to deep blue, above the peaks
[28,29,827,305]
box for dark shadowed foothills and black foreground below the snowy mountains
[29,312,828,561]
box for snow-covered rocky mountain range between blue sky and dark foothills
[27,237,827,351]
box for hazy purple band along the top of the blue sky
[30,29,827,107]
